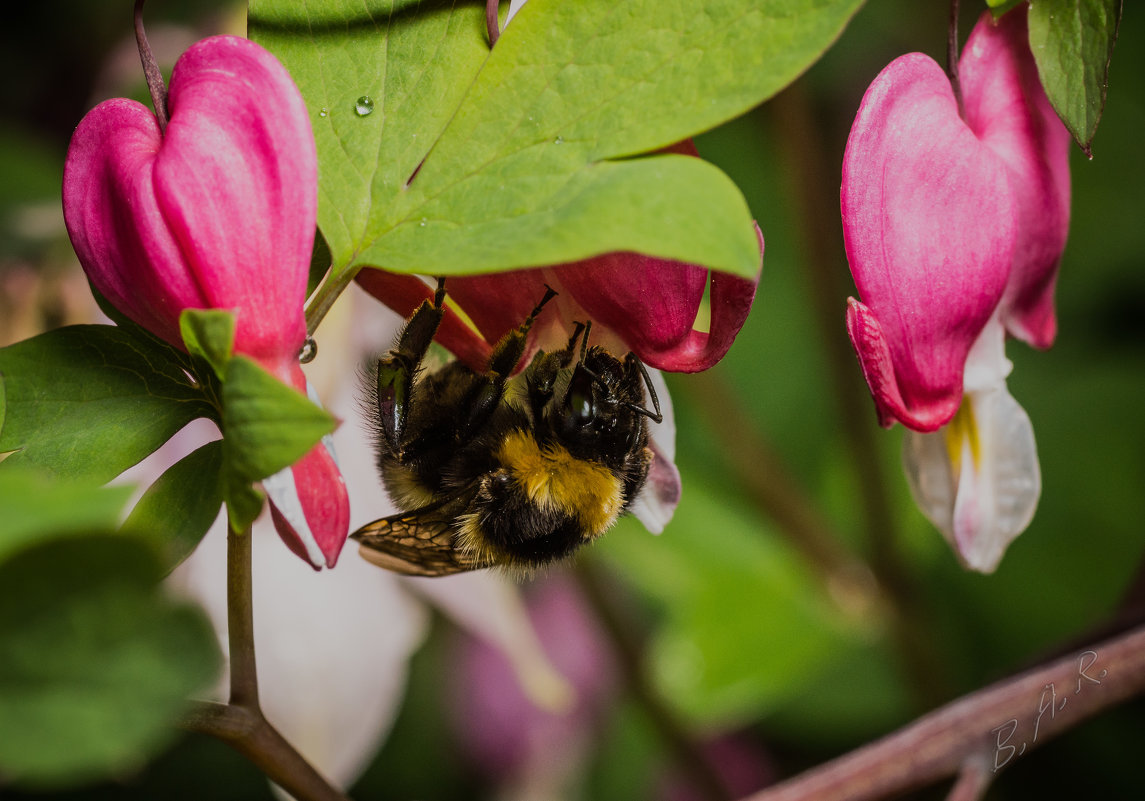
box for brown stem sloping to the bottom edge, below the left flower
[182,703,349,801]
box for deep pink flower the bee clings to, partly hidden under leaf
[356,142,764,533]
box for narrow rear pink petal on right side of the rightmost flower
[958,6,1069,348]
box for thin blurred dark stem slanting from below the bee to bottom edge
[573,558,731,801]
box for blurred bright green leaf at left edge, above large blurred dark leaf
[0,467,132,562]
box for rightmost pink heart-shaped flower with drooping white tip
[842,7,1069,572]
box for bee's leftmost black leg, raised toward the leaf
[377,278,445,453]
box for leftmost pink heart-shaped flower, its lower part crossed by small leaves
[63,37,349,566]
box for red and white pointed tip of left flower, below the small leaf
[262,436,350,570]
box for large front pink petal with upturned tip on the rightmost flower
[842,53,1017,430]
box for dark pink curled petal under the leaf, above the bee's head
[553,220,764,373]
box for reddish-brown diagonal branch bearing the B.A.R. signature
[748,626,1145,801]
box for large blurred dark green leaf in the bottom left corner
[0,536,221,786]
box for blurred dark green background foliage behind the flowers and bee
[0,0,1145,801]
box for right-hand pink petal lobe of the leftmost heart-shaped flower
[155,37,318,358]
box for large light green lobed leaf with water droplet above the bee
[250,0,861,277]
